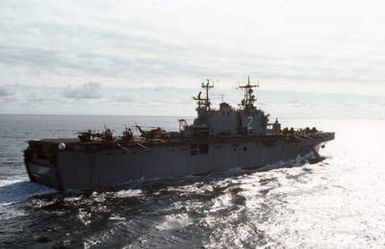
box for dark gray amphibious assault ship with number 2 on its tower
[24,78,334,190]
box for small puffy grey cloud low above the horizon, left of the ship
[63,82,102,99]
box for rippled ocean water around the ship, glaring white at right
[0,115,385,249]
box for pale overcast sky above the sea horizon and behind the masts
[0,0,385,119]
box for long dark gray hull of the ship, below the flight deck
[25,133,334,190]
